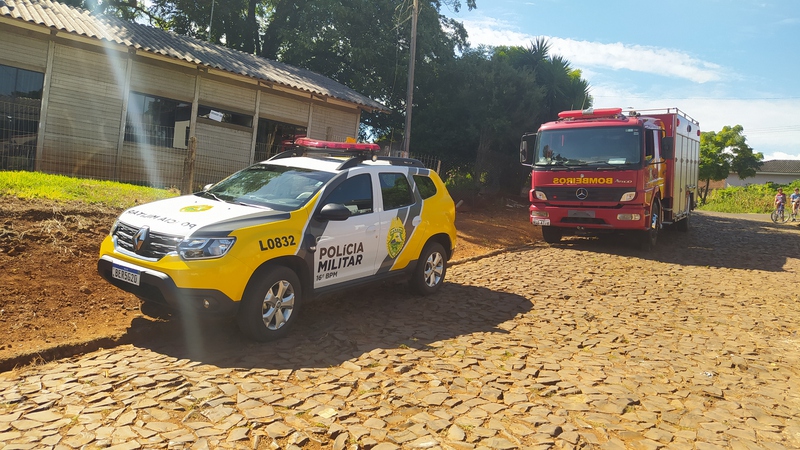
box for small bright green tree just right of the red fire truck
[698,125,764,203]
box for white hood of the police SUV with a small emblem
[119,195,290,237]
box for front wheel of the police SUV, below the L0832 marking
[236,266,302,342]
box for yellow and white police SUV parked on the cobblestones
[97,138,456,341]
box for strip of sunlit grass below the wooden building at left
[0,171,180,208]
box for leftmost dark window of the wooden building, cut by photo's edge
[0,64,44,170]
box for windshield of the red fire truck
[534,127,642,167]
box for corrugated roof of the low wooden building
[0,0,387,111]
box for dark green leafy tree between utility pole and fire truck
[412,40,591,193]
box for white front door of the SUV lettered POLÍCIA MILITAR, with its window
[313,173,379,289]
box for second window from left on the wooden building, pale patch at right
[125,92,192,148]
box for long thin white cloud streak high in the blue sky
[456,19,722,83]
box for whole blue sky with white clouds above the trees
[441,0,800,161]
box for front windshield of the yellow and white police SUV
[203,164,335,211]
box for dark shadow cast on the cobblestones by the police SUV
[119,283,531,369]
